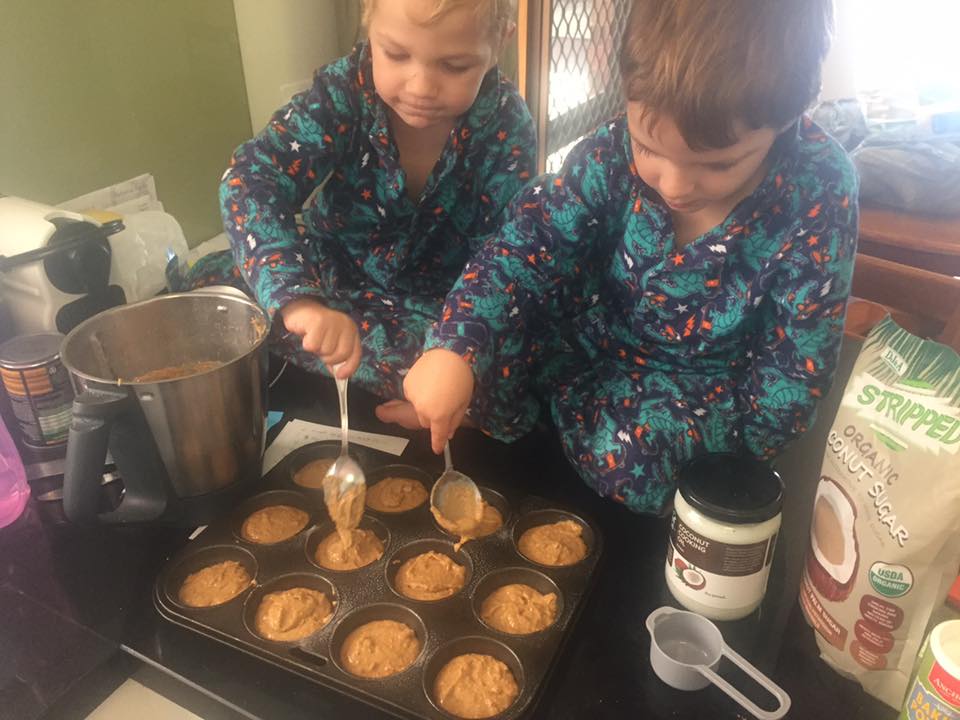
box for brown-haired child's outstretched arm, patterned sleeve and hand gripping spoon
[404,133,612,452]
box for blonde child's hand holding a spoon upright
[280,298,361,378]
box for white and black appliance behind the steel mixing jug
[0,195,126,335]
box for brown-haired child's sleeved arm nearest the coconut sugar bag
[739,165,858,457]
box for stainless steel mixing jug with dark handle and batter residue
[61,293,270,526]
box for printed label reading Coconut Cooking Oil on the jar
[667,512,777,608]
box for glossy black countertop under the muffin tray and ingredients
[0,347,896,720]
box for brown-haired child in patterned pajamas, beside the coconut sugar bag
[380,0,857,513]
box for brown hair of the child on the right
[620,0,833,150]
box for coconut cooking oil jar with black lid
[665,453,783,620]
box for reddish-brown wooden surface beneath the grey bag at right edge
[857,207,960,276]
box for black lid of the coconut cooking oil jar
[678,453,783,525]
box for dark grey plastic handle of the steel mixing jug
[63,389,129,523]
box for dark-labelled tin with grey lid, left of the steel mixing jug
[0,333,73,448]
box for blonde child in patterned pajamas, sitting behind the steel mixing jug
[189,0,536,398]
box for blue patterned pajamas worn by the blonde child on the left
[187,43,536,398]
